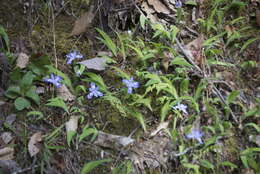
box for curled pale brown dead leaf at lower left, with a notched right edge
[28,132,42,157]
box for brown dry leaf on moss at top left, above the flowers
[70,6,95,36]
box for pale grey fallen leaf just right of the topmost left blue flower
[79,57,106,71]
